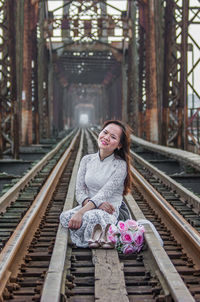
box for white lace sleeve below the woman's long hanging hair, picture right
[90,160,127,207]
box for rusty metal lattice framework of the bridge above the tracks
[0,0,200,158]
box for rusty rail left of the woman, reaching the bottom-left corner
[0,131,80,297]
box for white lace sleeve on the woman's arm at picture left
[76,155,89,204]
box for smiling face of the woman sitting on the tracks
[98,124,122,153]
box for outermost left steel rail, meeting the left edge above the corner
[0,131,75,212]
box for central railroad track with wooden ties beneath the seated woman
[0,131,200,302]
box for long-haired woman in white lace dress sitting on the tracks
[60,120,132,247]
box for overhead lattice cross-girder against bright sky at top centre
[44,0,129,43]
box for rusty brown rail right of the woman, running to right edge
[130,169,200,269]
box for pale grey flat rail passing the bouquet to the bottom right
[125,194,195,302]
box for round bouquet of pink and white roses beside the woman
[108,219,144,255]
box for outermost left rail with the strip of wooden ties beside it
[0,132,77,251]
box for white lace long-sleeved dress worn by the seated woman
[60,153,127,247]
